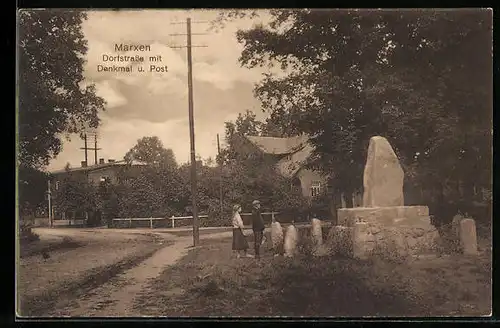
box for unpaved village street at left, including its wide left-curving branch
[18,228,241,317]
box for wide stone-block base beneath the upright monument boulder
[329,206,439,259]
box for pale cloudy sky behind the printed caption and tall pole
[48,10,274,170]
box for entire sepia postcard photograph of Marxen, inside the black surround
[15,8,493,319]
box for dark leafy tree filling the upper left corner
[18,10,105,168]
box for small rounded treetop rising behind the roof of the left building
[124,136,177,168]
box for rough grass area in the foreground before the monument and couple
[135,238,491,317]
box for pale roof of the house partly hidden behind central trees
[246,135,308,155]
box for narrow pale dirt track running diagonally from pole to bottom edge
[38,230,235,317]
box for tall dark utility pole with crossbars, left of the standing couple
[171,18,206,247]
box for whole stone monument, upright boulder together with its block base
[337,136,439,258]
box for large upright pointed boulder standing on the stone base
[363,136,404,207]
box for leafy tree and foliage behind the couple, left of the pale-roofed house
[209,110,306,223]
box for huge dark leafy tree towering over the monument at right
[216,10,492,218]
